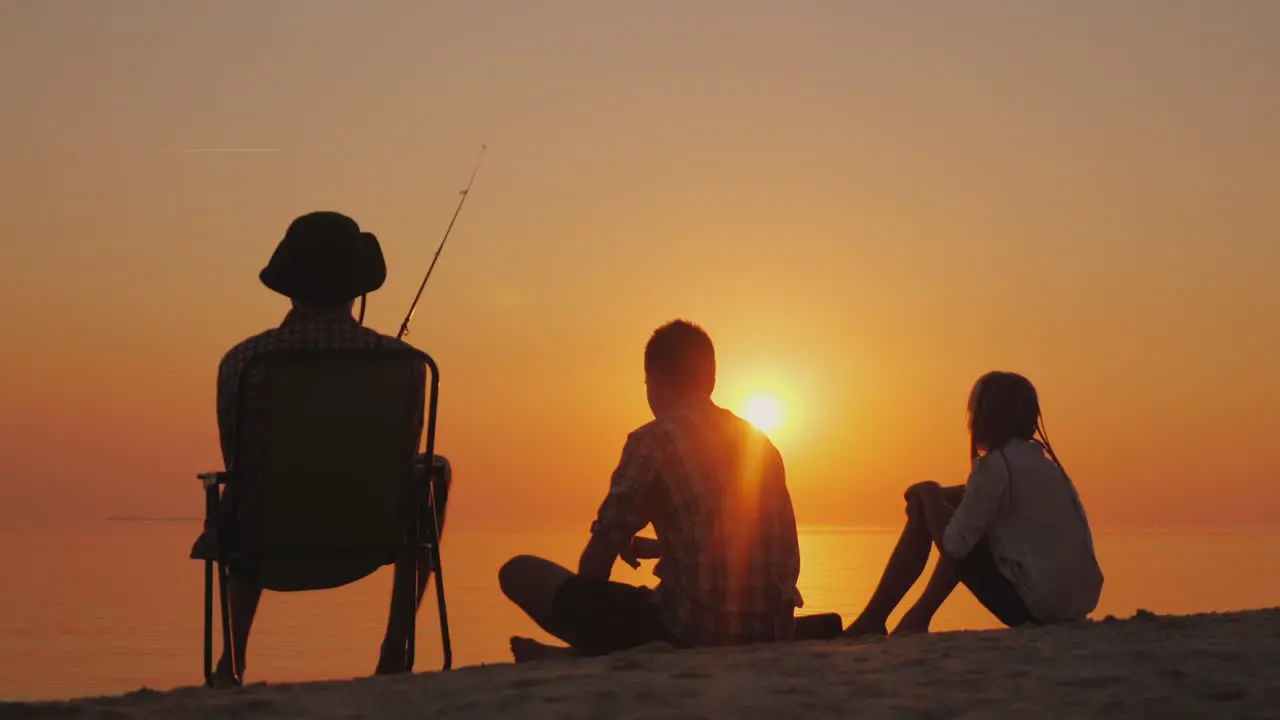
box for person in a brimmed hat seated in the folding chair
[191,211,451,684]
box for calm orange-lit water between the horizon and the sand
[0,521,1280,700]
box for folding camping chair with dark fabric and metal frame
[198,348,453,684]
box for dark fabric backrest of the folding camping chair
[236,348,435,589]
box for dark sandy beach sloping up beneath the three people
[0,609,1280,720]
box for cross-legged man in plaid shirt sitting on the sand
[498,320,801,661]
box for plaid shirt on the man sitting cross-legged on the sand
[593,400,803,646]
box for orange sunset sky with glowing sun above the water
[0,0,1280,530]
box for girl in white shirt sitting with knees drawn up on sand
[845,372,1102,635]
